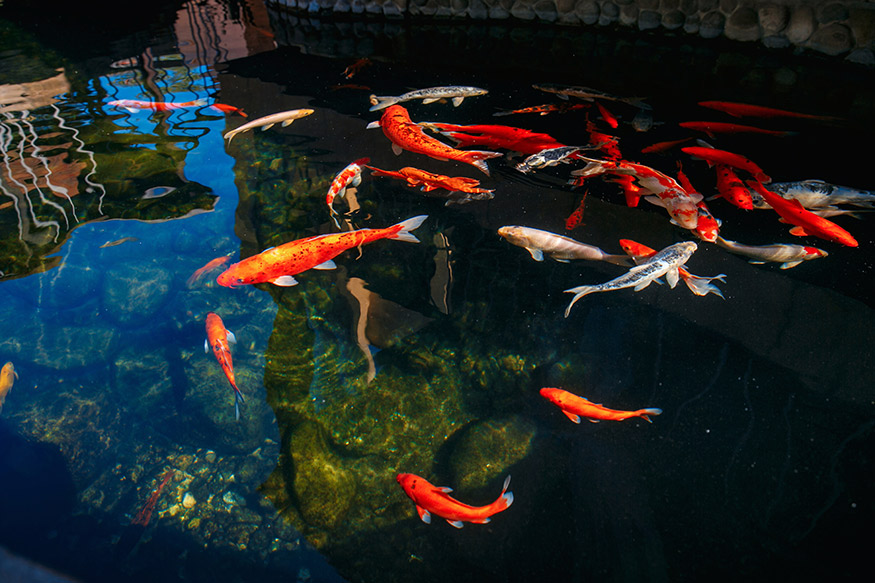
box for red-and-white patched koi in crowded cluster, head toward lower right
[571,155,702,230]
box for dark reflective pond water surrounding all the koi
[0,0,875,582]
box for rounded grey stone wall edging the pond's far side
[267,0,875,65]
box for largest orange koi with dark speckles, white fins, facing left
[216,215,427,287]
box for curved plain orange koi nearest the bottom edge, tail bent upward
[395,474,513,528]
